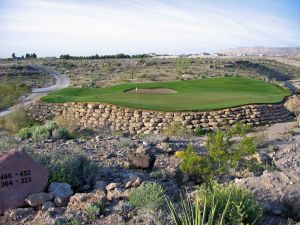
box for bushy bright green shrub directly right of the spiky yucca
[200,183,263,224]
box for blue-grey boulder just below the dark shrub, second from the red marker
[49,182,73,207]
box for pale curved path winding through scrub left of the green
[0,65,70,117]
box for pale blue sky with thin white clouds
[0,0,300,57]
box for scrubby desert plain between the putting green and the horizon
[42,57,300,87]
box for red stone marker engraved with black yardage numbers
[0,148,48,213]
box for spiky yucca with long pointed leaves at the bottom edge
[160,194,230,225]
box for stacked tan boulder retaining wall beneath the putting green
[29,101,293,134]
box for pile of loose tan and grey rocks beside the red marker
[4,174,143,224]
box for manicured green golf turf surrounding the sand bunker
[42,77,290,111]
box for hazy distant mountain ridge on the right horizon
[220,47,300,56]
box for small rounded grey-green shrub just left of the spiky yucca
[129,182,165,212]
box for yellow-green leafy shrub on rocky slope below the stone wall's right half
[176,131,257,181]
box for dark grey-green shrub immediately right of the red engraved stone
[44,155,98,189]
